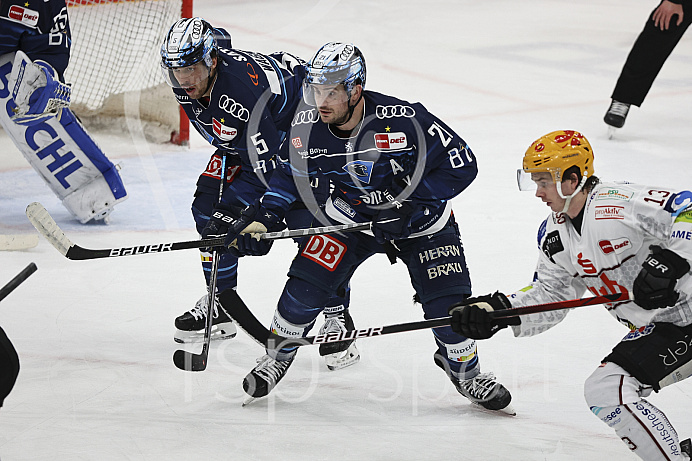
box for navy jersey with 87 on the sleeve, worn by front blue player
[263,91,477,237]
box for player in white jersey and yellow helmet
[450,131,692,460]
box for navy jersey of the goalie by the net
[0,0,71,79]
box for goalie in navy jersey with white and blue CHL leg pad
[0,0,127,223]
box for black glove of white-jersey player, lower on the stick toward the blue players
[449,291,521,339]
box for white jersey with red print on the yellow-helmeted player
[510,178,692,336]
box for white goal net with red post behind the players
[65,0,192,143]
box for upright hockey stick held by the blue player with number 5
[173,153,226,371]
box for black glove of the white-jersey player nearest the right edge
[632,245,690,310]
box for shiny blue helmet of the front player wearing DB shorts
[303,42,366,106]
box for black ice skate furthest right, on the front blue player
[434,352,517,416]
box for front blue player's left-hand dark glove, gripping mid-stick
[225,201,286,257]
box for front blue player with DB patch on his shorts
[226,43,514,414]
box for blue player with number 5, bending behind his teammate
[161,18,359,369]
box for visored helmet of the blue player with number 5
[161,18,217,88]
